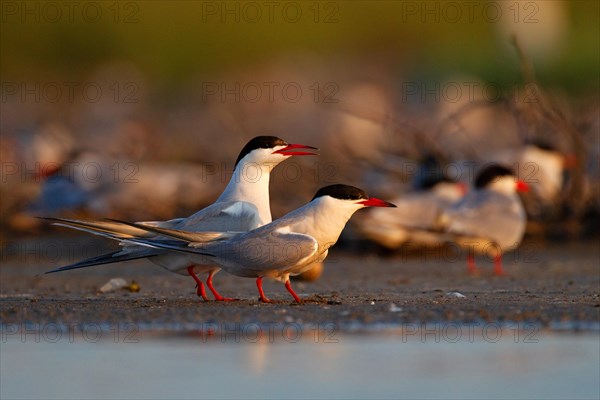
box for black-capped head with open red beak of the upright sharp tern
[235,136,317,167]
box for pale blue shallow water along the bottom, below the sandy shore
[0,326,600,399]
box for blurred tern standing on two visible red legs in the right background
[441,164,529,275]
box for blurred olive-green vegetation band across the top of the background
[1,0,600,93]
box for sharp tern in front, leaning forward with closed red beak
[119,184,395,303]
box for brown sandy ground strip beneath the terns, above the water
[0,236,600,331]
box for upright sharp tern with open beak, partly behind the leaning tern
[47,136,316,301]
